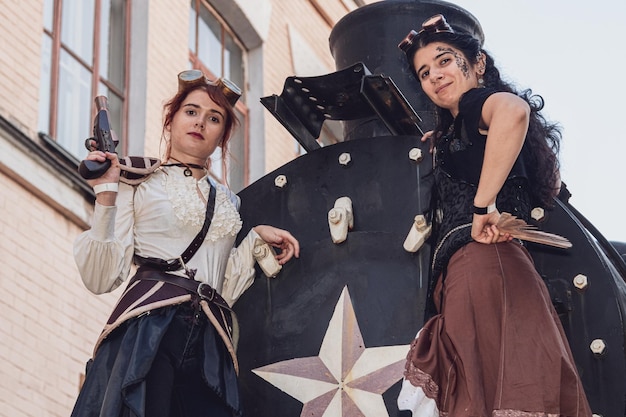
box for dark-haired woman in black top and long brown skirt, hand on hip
[398,15,591,417]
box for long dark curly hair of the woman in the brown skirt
[407,32,561,207]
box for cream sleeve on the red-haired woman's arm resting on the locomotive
[221,229,261,306]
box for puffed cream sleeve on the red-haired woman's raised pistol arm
[74,183,134,294]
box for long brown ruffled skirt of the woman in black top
[398,242,591,417]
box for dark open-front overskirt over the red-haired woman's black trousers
[72,302,242,417]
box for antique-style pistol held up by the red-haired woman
[78,96,119,180]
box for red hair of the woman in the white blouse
[161,83,239,169]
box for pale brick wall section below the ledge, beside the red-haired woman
[0,171,118,417]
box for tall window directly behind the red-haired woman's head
[189,0,249,191]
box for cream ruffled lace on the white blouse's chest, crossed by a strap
[163,167,242,237]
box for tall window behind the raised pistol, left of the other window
[38,0,130,160]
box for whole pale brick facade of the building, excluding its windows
[0,0,366,417]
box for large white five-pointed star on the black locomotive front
[252,287,409,417]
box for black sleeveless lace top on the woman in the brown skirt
[432,88,531,277]
